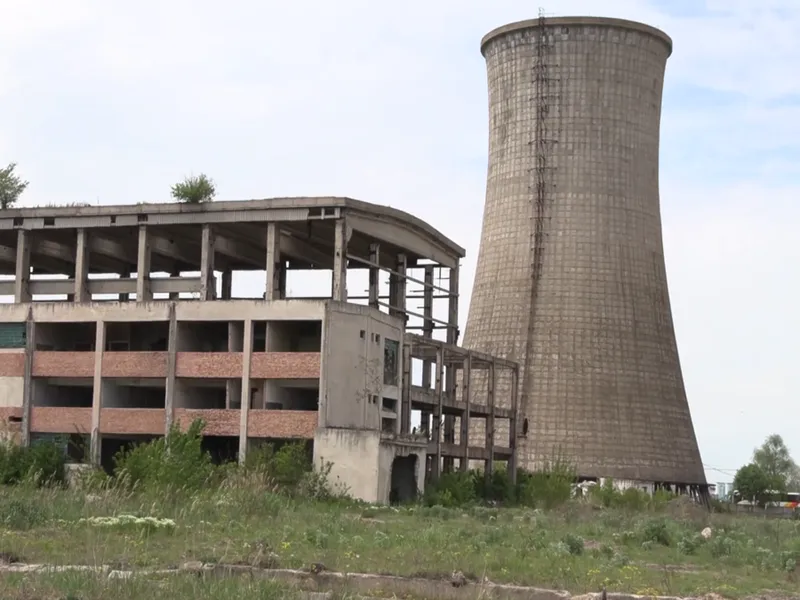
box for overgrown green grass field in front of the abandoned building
[0,480,800,600]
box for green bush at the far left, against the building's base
[0,440,66,486]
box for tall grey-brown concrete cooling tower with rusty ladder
[463,17,706,493]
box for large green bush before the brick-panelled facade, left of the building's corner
[114,419,214,490]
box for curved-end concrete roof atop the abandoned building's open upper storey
[0,197,466,272]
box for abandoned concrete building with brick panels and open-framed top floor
[0,198,519,502]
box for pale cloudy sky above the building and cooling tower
[0,0,800,482]
